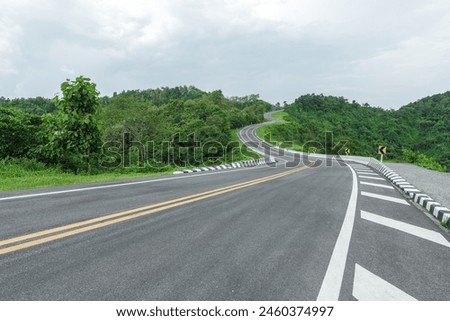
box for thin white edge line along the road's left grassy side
[0,167,256,201]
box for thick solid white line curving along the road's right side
[317,166,358,301]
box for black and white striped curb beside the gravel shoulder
[367,159,450,224]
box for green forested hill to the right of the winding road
[285,92,450,170]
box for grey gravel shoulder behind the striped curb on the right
[385,163,450,208]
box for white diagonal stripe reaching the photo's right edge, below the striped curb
[361,211,450,247]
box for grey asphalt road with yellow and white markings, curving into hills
[0,114,450,300]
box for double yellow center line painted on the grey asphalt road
[0,166,308,255]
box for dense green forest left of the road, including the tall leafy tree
[0,77,272,179]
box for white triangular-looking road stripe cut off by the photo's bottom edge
[353,264,417,301]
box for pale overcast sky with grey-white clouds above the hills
[0,0,450,109]
